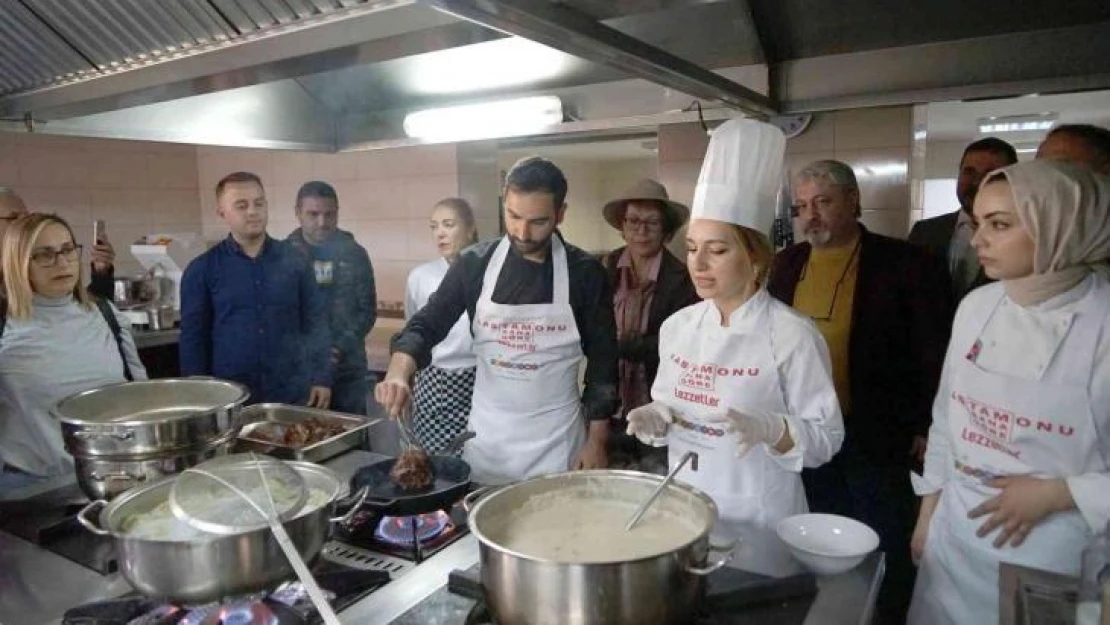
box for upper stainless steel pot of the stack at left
[53,377,250,456]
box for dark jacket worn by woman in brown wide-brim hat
[602,248,702,385]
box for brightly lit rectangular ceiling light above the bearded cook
[403,95,563,141]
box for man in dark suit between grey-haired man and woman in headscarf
[909,137,1018,302]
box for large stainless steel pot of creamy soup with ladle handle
[464,470,731,625]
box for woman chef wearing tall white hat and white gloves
[628,120,844,527]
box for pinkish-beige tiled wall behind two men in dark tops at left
[198,145,460,302]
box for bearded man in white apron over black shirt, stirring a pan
[374,157,619,484]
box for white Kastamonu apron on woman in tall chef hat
[652,298,808,527]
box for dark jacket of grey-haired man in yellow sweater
[767,226,955,466]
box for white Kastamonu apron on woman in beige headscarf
[908,290,1107,625]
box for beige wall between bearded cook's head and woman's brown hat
[501,154,656,253]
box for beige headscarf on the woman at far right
[983,160,1110,306]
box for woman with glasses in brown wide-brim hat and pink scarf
[602,180,699,471]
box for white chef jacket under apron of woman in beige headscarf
[915,274,1110,532]
